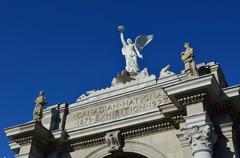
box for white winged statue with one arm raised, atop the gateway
[118,26,153,73]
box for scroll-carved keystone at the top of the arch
[105,130,124,153]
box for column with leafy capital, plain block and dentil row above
[177,92,217,158]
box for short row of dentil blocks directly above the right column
[178,92,207,106]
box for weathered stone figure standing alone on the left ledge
[33,91,47,122]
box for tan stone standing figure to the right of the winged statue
[180,42,198,76]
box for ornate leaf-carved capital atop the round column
[182,125,217,155]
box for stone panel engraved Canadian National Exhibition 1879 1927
[70,89,171,127]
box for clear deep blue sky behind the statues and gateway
[0,0,240,157]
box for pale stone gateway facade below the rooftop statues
[5,62,240,158]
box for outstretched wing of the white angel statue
[135,35,153,51]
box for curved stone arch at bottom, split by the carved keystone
[85,141,167,158]
